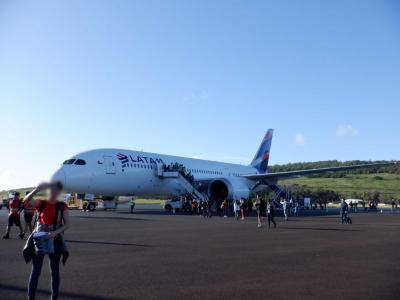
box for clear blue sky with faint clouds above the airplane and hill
[0,0,400,190]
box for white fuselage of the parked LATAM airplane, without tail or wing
[52,149,258,199]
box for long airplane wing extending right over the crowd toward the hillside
[241,162,398,180]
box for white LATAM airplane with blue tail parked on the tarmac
[51,129,395,201]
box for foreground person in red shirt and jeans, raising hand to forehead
[24,183,70,300]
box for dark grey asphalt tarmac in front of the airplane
[0,206,400,300]
